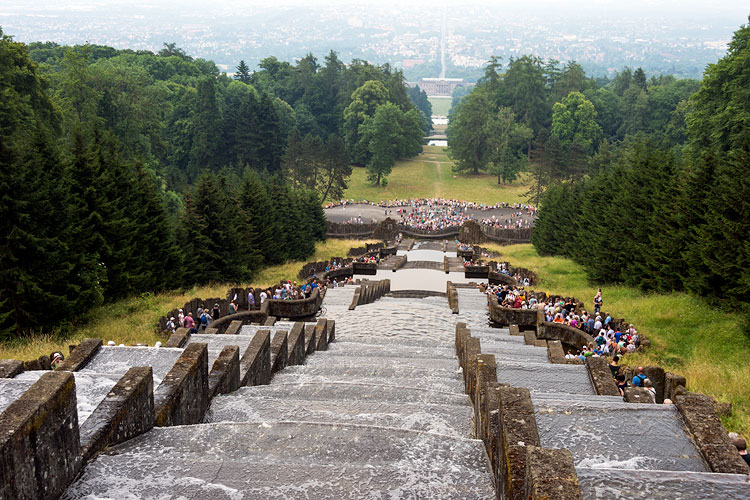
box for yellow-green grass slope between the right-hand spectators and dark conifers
[488,245,750,437]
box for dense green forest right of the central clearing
[449,17,750,313]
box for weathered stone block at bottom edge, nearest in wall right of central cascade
[524,446,583,500]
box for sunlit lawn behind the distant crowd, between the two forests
[344,146,529,203]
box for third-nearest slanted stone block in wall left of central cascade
[154,343,209,427]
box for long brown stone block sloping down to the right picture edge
[674,392,750,474]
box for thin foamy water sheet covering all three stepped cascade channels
[54,280,750,500]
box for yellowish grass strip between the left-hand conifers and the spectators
[0,239,365,360]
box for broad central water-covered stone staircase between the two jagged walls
[63,287,496,500]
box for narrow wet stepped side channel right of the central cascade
[458,289,750,500]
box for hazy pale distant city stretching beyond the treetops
[0,0,747,81]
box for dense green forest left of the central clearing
[0,31,429,338]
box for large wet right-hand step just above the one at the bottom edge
[534,397,708,472]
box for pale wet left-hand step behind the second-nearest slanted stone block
[80,346,182,389]
